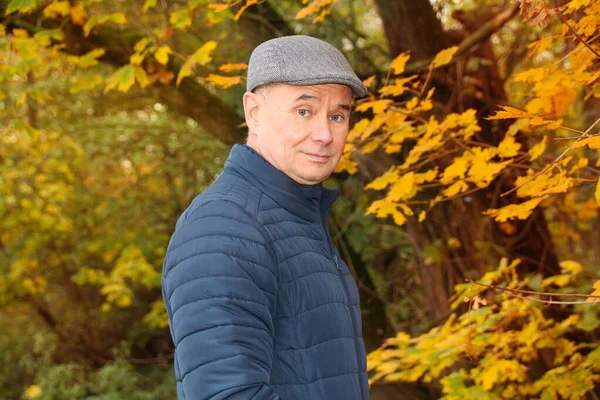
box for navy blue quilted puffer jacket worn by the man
[163,145,369,400]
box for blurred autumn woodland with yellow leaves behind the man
[0,0,600,400]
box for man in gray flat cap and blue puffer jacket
[163,36,369,400]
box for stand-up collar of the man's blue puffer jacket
[225,144,339,222]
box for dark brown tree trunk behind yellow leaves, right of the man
[375,0,559,321]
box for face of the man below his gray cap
[244,84,352,184]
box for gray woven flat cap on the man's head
[246,35,367,97]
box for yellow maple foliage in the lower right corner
[369,259,600,400]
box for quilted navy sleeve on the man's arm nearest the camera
[163,200,279,400]
